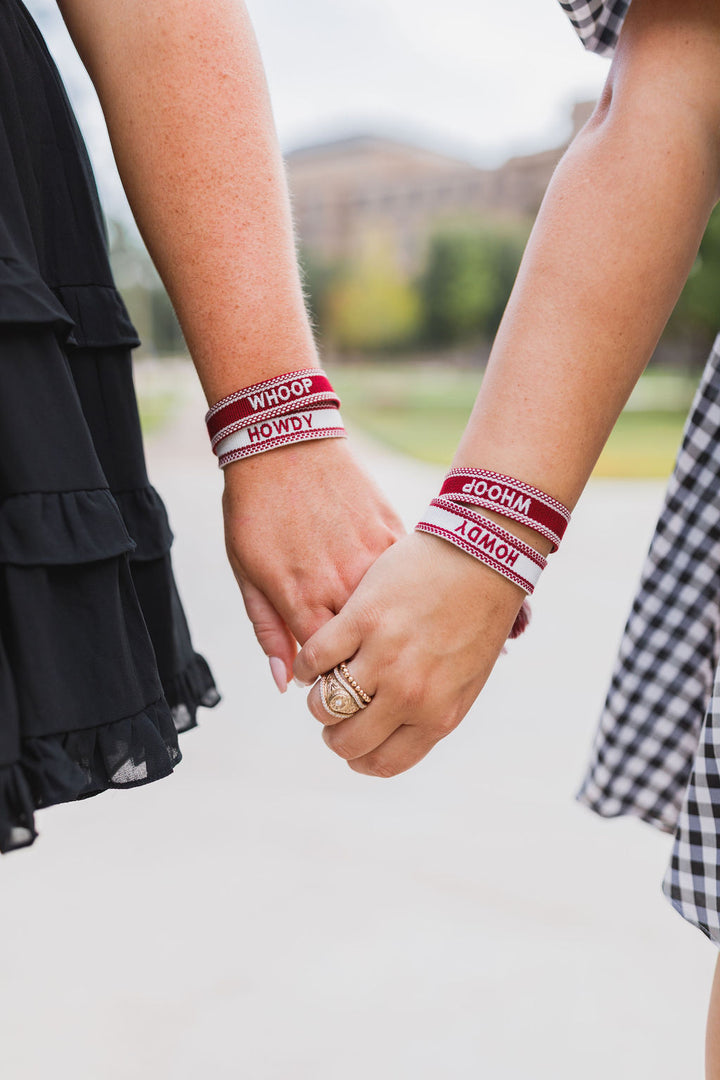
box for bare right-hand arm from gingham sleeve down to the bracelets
[456,0,720,527]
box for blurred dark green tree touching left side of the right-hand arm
[419,225,529,346]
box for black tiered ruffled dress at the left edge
[0,0,218,852]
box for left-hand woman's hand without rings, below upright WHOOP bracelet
[222,438,404,689]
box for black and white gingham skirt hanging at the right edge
[576,336,720,947]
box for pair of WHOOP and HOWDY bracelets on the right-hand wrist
[416,469,570,594]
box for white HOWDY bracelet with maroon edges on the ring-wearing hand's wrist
[416,497,547,594]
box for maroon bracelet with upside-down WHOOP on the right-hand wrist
[440,469,570,551]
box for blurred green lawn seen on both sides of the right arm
[331,363,696,478]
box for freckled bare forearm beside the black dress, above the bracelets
[60,0,317,402]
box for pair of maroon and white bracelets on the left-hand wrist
[205,367,345,469]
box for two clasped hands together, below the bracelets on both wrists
[223,440,522,777]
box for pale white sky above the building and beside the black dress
[26,0,608,221]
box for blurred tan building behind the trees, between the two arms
[286,102,594,272]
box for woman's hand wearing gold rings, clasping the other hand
[295,532,524,777]
